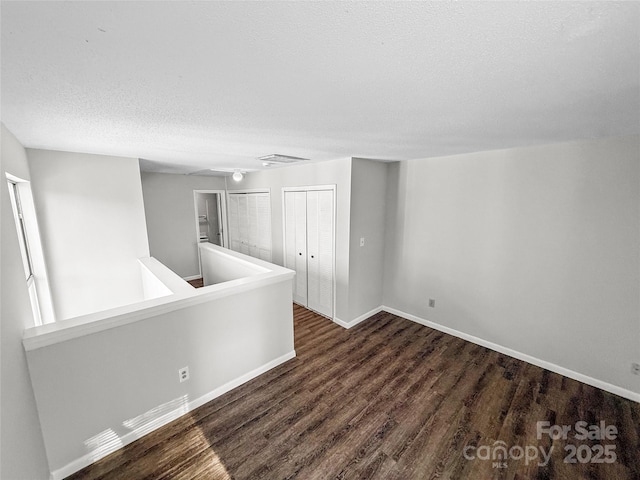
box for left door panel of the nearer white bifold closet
[284,192,307,307]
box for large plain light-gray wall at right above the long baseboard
[384,136,640,392]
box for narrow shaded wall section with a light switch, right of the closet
[349,158,389,320]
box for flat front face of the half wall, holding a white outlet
[26,282,294,478]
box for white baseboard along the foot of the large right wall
[381,305,640,402]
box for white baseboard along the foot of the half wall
[49,350,296,480]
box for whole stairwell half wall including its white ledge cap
[23,242,295,478]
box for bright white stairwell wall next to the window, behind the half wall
[27,149,149,319]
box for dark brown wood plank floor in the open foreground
[69,306,640,480]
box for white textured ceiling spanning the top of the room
[0,1,640,172]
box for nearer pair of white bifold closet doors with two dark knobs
[283,185,335,318]
